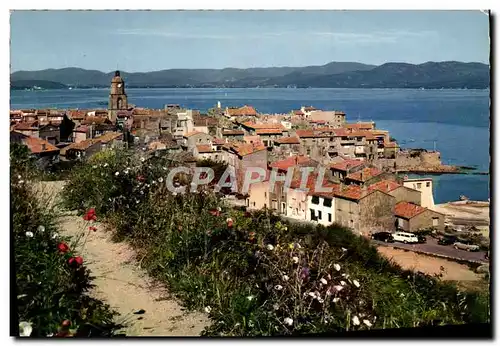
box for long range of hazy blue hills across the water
[11,61,490,89]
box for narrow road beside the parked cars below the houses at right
[372,237,488,263]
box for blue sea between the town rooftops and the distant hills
[10,88,490,203]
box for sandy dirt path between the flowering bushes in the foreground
[37,182,209,336]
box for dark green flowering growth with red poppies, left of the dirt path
[10,148,122,337]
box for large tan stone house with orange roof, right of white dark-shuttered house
[335,185,396,235]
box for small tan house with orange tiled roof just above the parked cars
[394,202,445,232]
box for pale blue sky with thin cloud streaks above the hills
[11,11,489,72]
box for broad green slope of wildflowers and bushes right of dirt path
[61,148,489,336]
